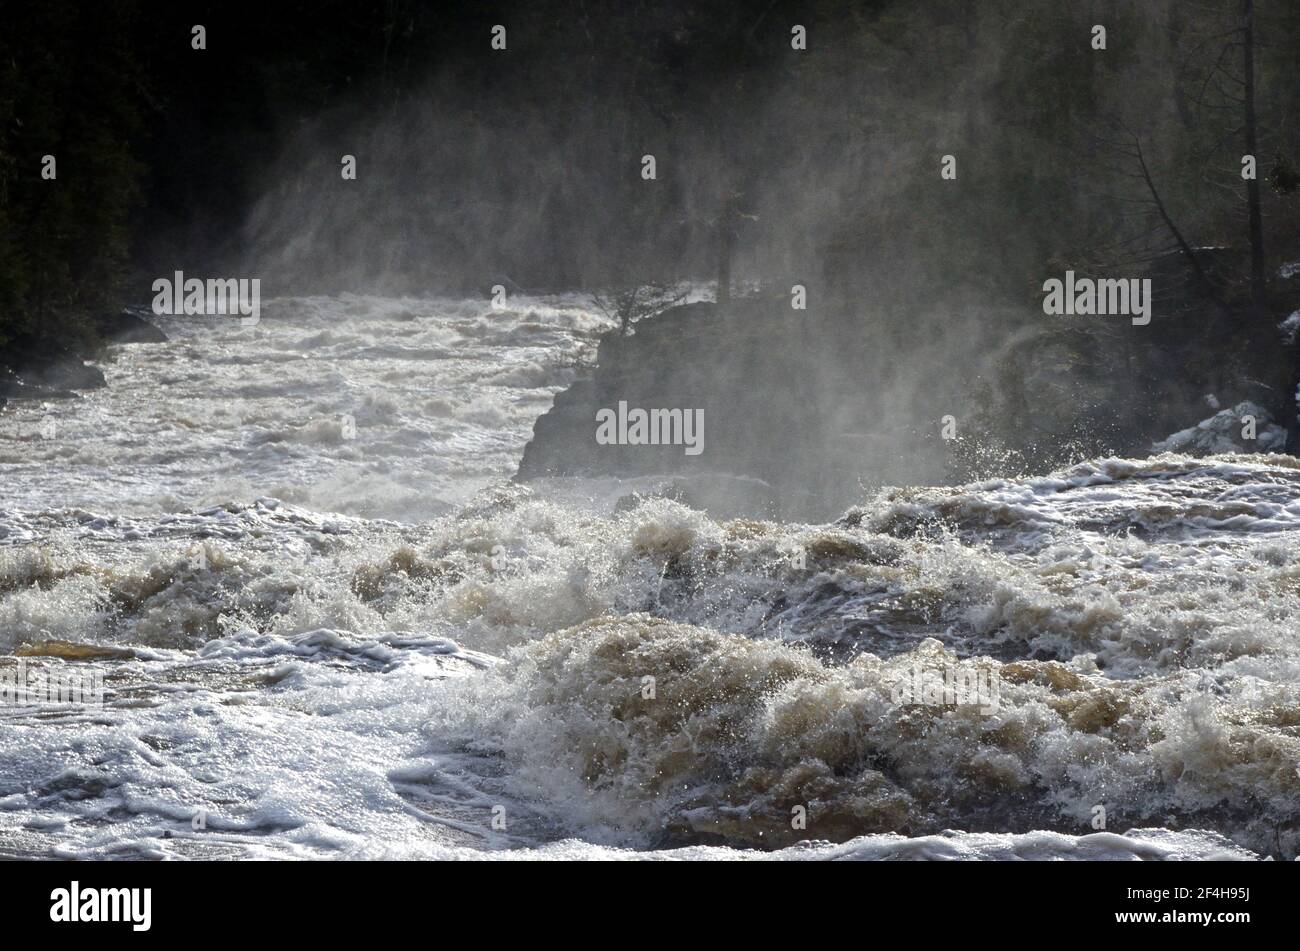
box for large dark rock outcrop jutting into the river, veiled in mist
[517,298,915,518]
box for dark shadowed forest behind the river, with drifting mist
[0,0,1300,468]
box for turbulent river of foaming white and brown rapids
[0,296,1300,859]
